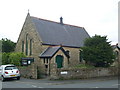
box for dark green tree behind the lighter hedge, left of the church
[2,38,16,53]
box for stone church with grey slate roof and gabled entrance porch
[16,13,90,75]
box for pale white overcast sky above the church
[0,0,119,44]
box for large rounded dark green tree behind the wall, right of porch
[82,35,115,67]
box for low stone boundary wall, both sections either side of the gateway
[18,64,119,79]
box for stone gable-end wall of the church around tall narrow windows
[15,15,43,75]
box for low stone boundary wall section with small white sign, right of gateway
[51,67,118,79]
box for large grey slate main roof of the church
[31,16,90,47]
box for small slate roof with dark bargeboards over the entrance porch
[39,46,69,58]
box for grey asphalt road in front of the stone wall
[2,77,120,88]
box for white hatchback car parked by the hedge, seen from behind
[0,64,20,81]
